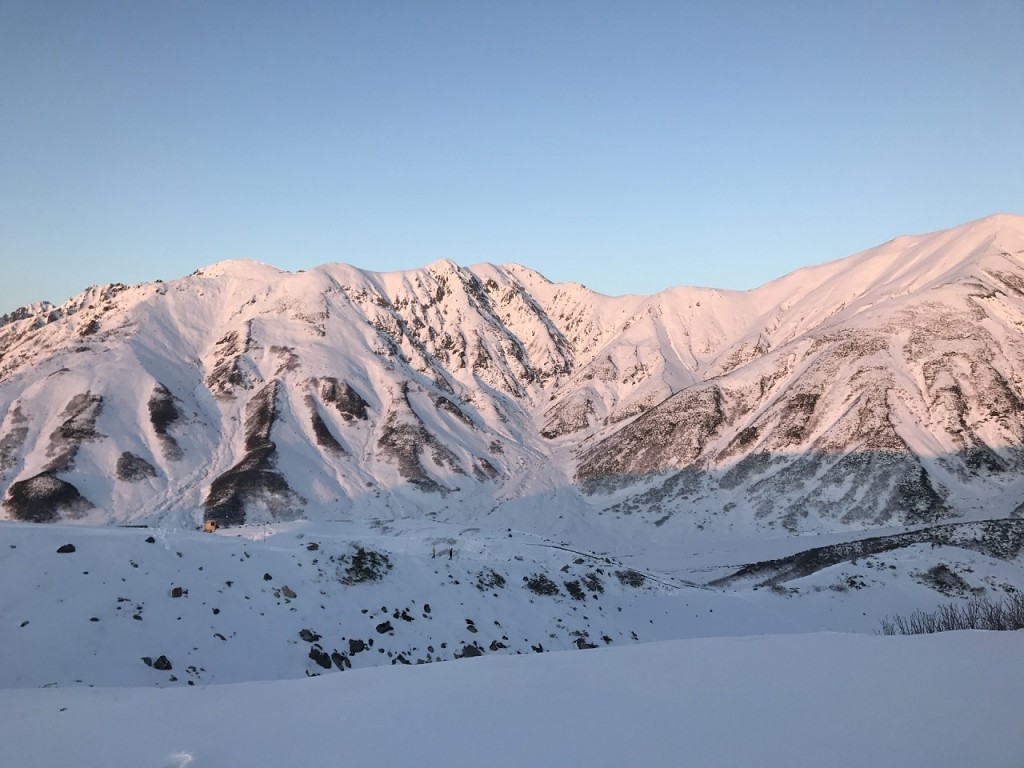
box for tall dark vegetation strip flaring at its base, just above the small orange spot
[203,379,305,526]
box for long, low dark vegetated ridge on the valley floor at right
[709,518,1024,587]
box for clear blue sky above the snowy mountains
[0,0,1024,312]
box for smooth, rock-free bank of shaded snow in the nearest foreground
[0,632,1024,768]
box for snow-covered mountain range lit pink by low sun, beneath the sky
[0,215,1024,536]
